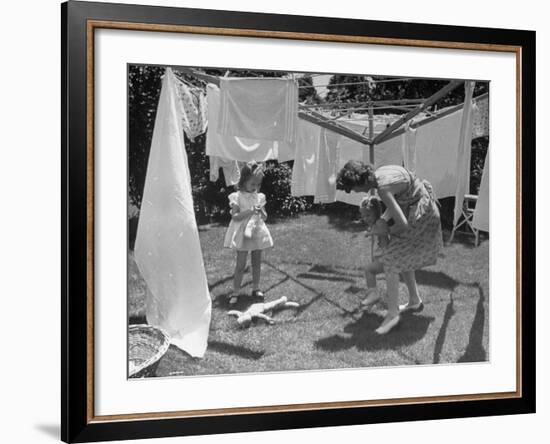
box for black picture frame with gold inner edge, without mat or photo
[61,1,535,442]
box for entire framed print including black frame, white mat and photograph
[61,1,535,442]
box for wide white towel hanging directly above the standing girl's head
[218,77,298,143]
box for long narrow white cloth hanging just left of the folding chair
[454,82,475,227]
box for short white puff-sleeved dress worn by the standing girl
[223,191,273,251]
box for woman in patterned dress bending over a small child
[337,160,443,334]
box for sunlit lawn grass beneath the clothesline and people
[128,214,489,376]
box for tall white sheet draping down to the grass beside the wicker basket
[134,69,211,357]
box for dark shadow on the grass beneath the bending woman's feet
[315,312,435,352]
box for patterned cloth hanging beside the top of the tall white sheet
[174,76,207,141]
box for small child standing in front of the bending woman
[359,195,390,307]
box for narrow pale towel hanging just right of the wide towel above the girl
[291,119,321,196]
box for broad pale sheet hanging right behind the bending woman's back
[416,110,468,199]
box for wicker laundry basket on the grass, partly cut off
[128,324,170,378]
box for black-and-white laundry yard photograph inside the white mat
[127,64,491,378]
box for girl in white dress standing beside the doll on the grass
[224,162,273,304]
